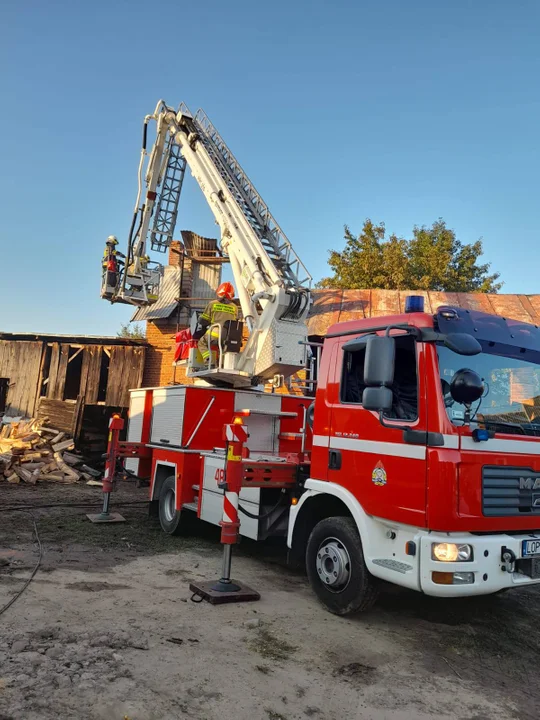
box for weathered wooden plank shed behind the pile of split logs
[0,333,146,450]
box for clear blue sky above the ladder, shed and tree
[0,0,540,334]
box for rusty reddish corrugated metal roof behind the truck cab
[308,289,540,335]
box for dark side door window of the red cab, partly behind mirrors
[341,335,418,420]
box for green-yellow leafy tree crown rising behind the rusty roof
[317,219,502,293]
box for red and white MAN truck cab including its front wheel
[288,298,540,614]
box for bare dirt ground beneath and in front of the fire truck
[0,483,540,720]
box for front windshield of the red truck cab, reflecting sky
[437,346,540,435]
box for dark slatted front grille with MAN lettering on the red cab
[482,465,540,517]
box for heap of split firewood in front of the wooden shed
[0,418,99,485]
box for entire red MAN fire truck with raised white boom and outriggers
[100,101,540,615]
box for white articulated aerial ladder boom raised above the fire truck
[101,100,312,387]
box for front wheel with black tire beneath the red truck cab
[306,517,378,615]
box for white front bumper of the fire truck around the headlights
[417,532,540,597]
